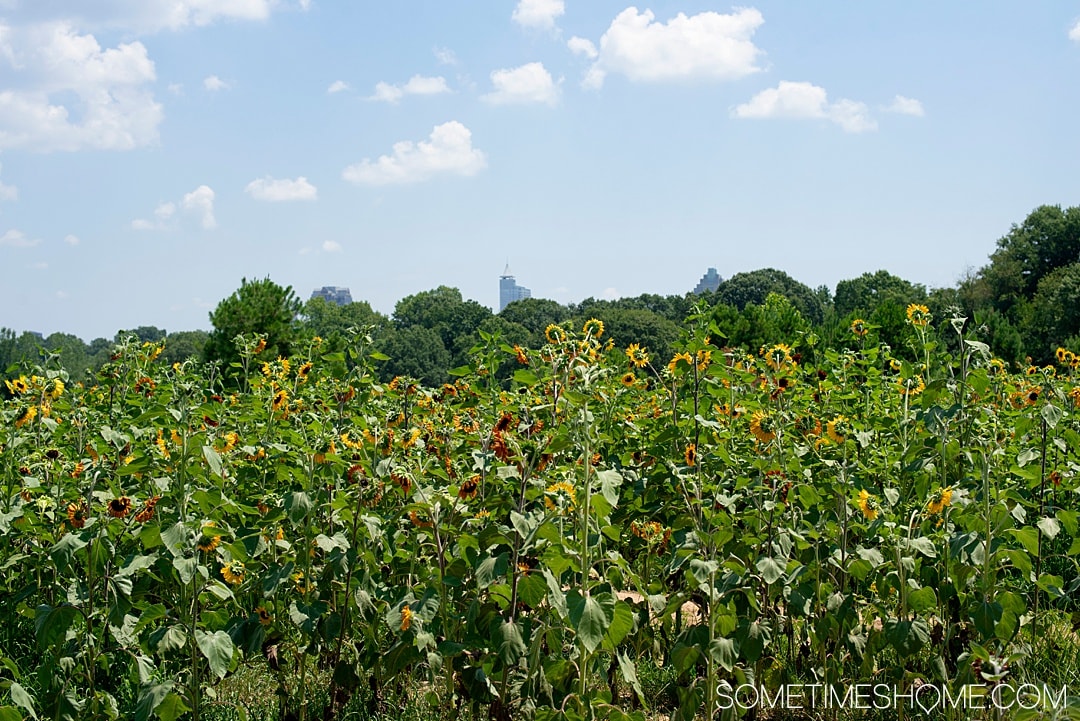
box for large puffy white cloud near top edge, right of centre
[582,8,765,89]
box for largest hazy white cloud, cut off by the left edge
[0,23,163,152]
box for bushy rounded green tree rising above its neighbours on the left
[203,277,300,375]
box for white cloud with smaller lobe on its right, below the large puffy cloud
[731,81,877,133]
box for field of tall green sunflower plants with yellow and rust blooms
[6,304,1080,721]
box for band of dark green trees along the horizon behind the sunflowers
[0,205,1080,384]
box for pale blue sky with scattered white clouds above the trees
[0,0,1080,341]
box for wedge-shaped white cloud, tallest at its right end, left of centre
[341,120,487,186]
